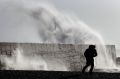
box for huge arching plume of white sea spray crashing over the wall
[0,0,114,69]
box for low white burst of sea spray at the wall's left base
[4,48,48,70]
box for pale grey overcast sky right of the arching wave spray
[50,0,120,44]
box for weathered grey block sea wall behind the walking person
[0,43,116,71]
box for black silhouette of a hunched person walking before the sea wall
[82,45,97,74]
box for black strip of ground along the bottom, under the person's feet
[0,70,120,79]
